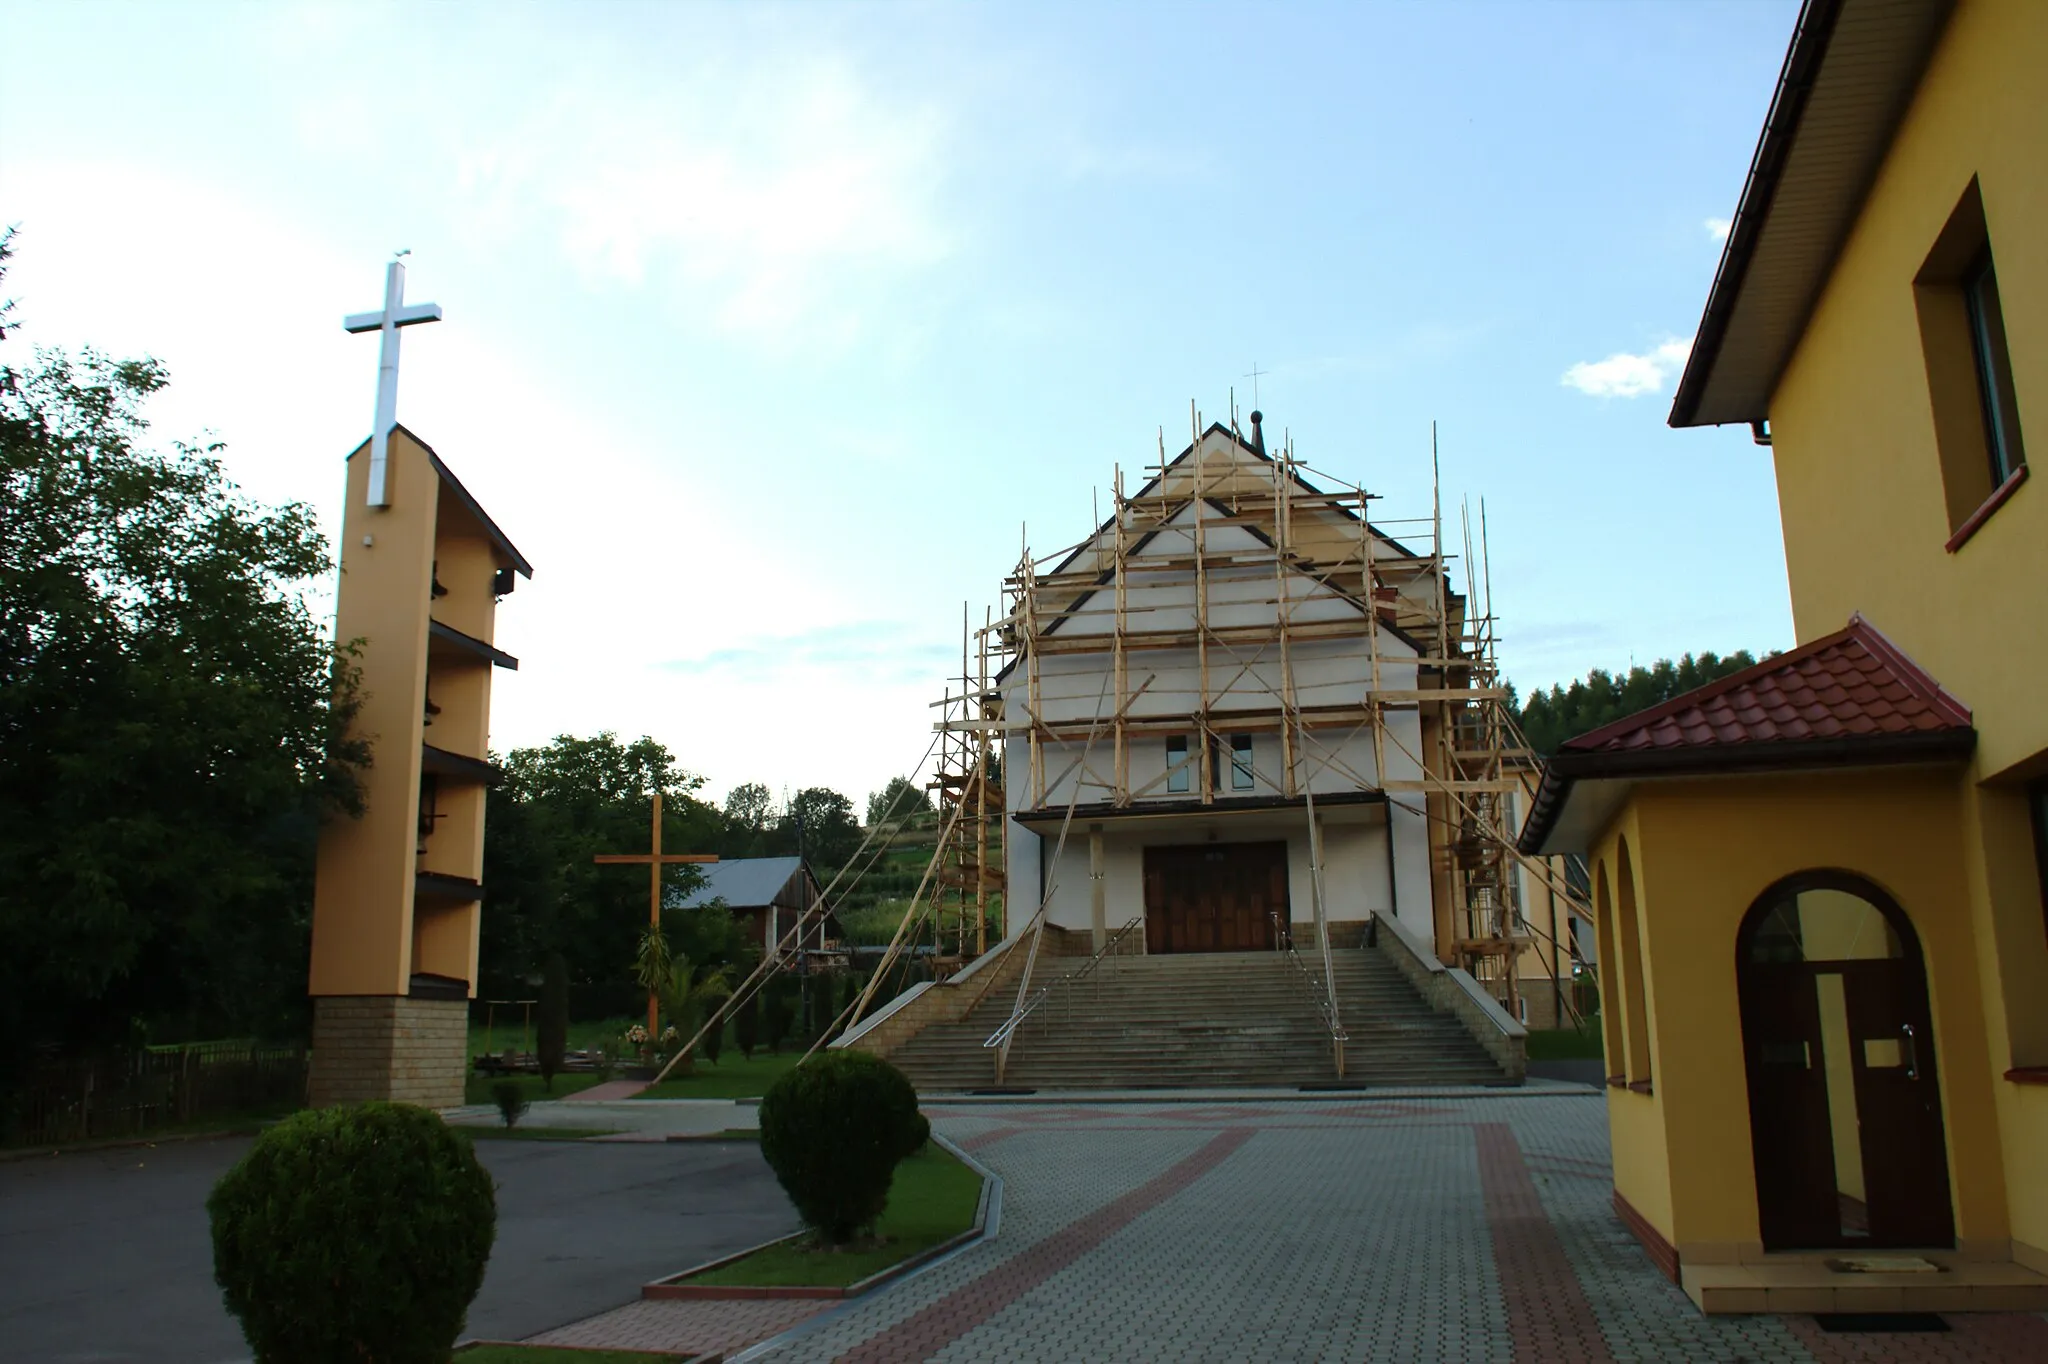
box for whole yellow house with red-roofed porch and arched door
[1522,0,2048,1311]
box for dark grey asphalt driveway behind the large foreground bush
[0,1139,797,1364]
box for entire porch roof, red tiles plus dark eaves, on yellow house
[1518,614,1976,854]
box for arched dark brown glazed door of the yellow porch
[1737,872,1956,1249]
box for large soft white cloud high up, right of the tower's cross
[440,55,950,344]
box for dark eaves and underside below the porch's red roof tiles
[1516,729,1976,856]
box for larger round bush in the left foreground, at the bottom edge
[207,1104,498,1364]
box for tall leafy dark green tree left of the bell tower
[0,233,369,1092]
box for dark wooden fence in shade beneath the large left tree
[8,1042,307,1145]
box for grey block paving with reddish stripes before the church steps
[535,1090,2048,1364]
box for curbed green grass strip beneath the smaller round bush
[690,1145,981,1288]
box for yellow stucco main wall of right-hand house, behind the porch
[1769,0,2048,1247]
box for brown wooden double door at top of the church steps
[1145,842,1288,952]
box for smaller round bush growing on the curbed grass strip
[760,1051,932,1245]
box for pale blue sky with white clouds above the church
[0,0,1796,807]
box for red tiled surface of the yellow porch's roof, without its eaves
[1559,614,1970,754]
